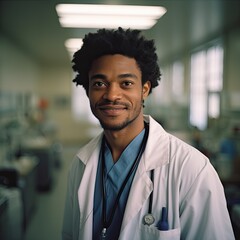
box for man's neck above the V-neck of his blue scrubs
[104,121,144,162]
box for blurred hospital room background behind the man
[0,0,240,240]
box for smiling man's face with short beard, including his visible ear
[88,54,150,131]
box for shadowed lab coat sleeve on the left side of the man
[62,158,84,240]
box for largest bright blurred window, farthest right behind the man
[190,44,223,130]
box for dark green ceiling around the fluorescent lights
[0,0,240,66]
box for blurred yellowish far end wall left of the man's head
[38,64,95,144]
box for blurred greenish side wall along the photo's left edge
[0,34,39,162]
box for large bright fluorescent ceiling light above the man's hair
[56,4,166,29]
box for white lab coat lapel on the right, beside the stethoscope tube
[121,117,169,231]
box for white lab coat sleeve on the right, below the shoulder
[180,158,235,240]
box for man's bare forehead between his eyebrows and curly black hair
[90,54,140,74]
